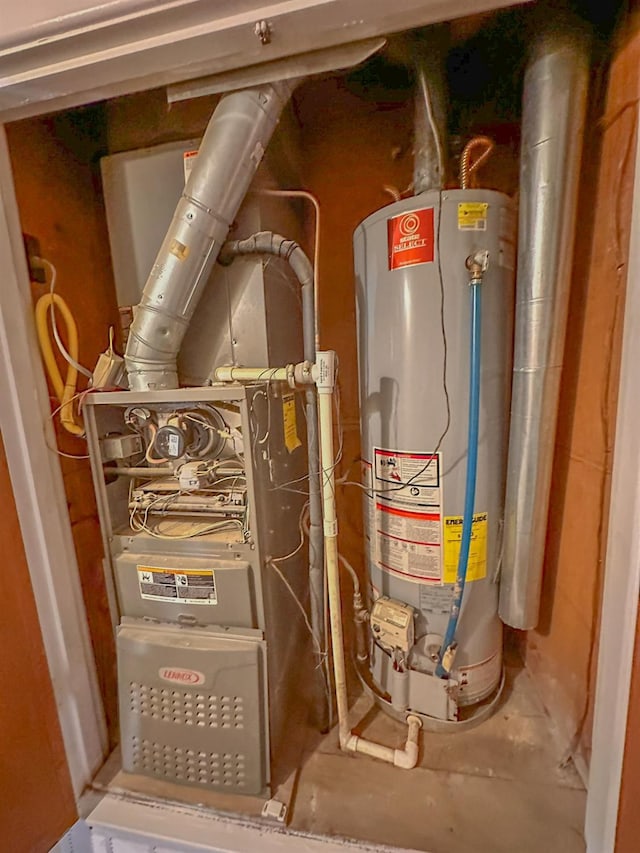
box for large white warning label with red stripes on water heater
[372,447,442,583]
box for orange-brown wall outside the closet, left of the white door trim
[0,441,77,853]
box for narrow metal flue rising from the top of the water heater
[413,27,448,195]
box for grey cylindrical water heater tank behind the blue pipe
[354,189,515,720]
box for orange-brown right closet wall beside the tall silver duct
[526,10,640,770]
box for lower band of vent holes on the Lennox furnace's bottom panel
[131,736,246,788]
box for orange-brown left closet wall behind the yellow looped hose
[7,109,118,741]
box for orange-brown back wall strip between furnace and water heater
[295,79,413,600]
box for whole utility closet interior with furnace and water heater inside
[2,0,637,853]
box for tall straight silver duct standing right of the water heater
[500,22,589,629]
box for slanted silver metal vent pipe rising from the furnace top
[125,81,299,391]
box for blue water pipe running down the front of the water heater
[436,281,482,678]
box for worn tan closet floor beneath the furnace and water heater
[94,658,586,853]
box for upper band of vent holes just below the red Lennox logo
[129,681,244,729]
